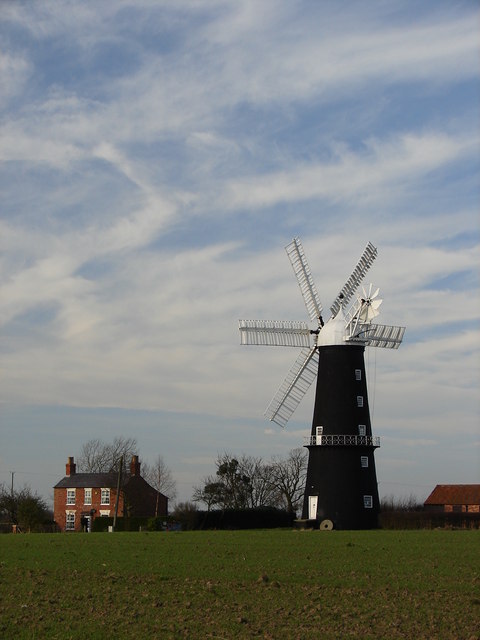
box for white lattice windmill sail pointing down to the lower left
[265,347,318,428]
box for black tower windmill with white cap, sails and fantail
[239,238,405,529]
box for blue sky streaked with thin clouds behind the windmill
[0,0,480,510]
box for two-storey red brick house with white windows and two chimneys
[53,456,168,531]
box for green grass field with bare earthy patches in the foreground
[0,530,480,640]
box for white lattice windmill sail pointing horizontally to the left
[238,320,311,347]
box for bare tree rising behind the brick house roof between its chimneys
[77,436,137,473]
